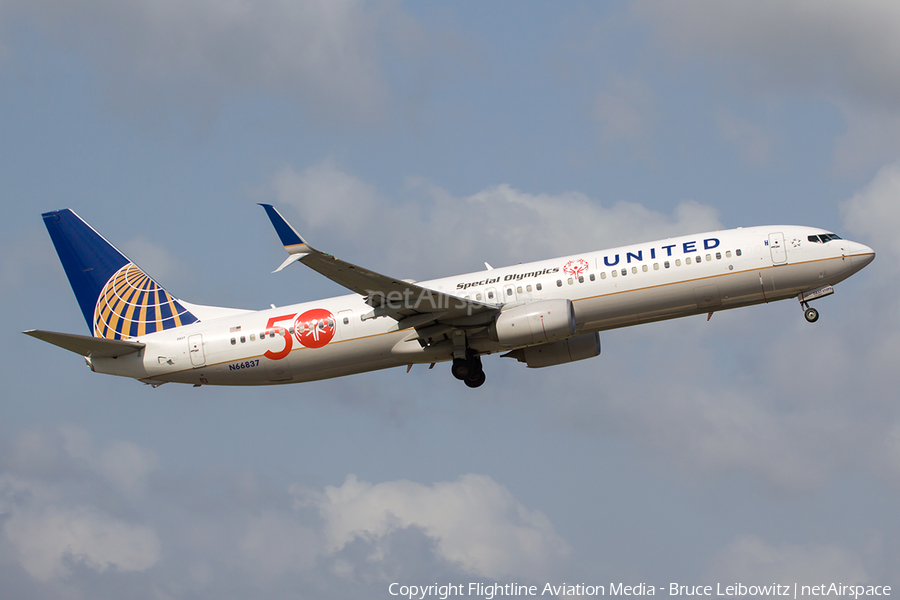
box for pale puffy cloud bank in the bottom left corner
[0,427,161,581]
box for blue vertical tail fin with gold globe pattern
[41,208,198,340]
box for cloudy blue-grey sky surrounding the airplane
[0,0,900,600]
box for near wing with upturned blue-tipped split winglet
[261,204,500,328]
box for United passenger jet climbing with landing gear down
[23,204,875,388]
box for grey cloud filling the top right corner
[633,0,900,172]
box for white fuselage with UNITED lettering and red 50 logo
[91,226,874,385]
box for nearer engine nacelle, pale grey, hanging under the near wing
[490,298,575,346]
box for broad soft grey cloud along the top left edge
[0,0,423,123]
